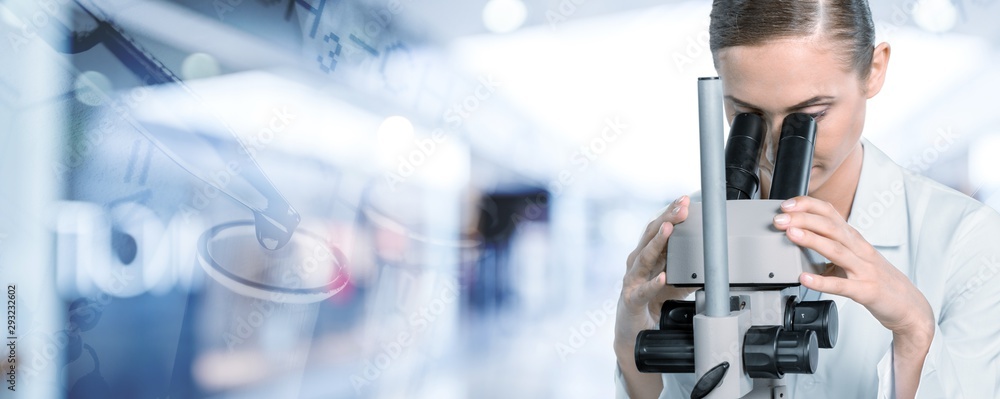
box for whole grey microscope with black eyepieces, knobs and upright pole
[635,77,838,399]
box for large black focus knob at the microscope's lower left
[635,330,694,373]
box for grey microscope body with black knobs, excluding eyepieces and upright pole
[636,200,838,398]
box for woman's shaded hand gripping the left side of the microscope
[615,196,694,398]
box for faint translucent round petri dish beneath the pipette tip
[198,220,350,303]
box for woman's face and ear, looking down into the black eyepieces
[716,37,888,196]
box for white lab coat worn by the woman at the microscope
[616,140,1000,399]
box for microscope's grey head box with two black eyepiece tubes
[667,113,822,288]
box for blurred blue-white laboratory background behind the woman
[0,0,1000,399]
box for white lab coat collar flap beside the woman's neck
[847,138,909,247]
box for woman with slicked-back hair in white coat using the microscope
[615,0,1000,398]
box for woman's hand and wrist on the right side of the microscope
[774,196,934,398]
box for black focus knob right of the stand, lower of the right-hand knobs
[743,326,819,378]
